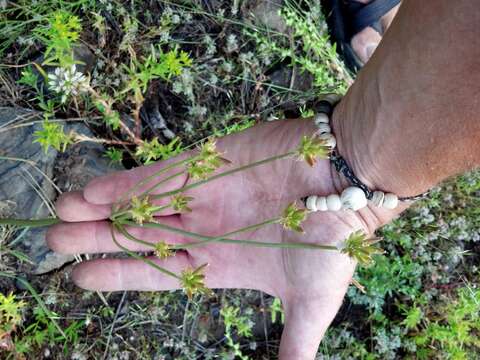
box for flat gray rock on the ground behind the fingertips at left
[0,107,124,274]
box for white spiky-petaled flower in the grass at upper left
[48,65,88,103]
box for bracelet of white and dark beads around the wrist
[305,95,428,212]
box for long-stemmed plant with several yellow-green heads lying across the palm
[0,135,381,298]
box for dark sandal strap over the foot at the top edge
[349,0,400,34]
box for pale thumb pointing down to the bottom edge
[279,291,345,360]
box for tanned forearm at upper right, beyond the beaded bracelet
[333,0,480,200]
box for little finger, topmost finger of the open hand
[83,152,191,205]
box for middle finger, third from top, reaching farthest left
[46,216,186,254]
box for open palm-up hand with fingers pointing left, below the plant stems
[47,120,390,360]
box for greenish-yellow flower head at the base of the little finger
[188,139,226,179]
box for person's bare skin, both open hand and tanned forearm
[47,0,480,360]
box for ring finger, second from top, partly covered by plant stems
[55,191,176,222]
